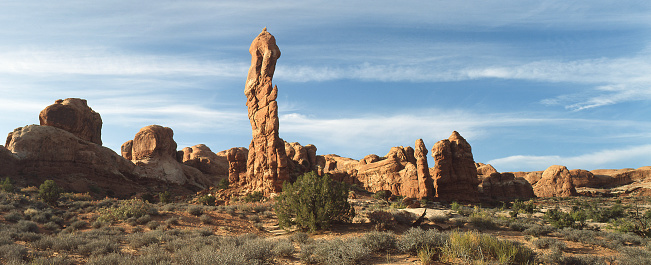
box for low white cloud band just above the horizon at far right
[487,145,651,171]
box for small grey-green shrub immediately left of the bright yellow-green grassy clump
[396,228,447,254]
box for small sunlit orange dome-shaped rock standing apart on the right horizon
[533,165,577,197]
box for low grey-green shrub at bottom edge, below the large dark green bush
[299,239,371,265]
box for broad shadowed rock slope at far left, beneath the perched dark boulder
[6,125,135,194]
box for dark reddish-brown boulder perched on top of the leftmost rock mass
[38,98,102,145]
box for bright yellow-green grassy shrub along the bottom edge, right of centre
[441,228,536,264]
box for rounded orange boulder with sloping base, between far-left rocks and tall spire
[121,125,211,188]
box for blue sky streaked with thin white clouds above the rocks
[0,0,651,172]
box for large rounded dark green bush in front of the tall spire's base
[274,172,355,232]
